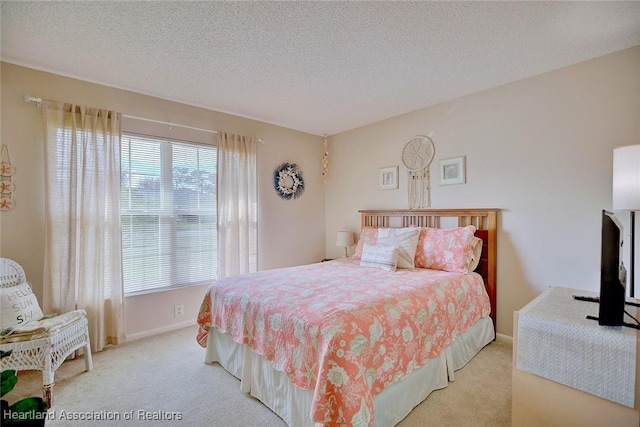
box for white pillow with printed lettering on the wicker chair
[0,282,43,329]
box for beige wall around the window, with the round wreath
[0,63,325,338]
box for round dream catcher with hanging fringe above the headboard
[402,135,436,209]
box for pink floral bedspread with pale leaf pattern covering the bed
[197,259,490,426]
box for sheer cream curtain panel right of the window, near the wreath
[217,133,258,278]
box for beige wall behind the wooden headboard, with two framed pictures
[326,46,640,336]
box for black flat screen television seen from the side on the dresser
[598,210,626,326]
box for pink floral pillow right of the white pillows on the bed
[416,225,476,274]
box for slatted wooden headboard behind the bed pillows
[359,208,500,328]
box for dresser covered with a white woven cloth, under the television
[512,287,640,427]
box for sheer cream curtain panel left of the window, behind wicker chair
[43,101,124,351]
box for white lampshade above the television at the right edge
[612,145,640,211]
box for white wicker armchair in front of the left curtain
[0,258,93,407]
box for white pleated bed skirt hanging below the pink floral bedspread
[205,317,495,427]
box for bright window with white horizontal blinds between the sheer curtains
[120,134,217,295]
